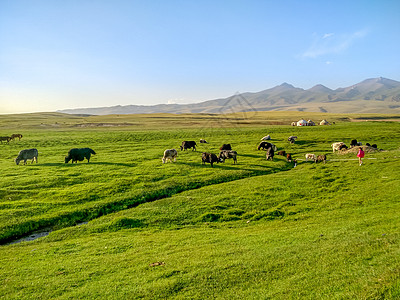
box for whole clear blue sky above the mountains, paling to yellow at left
[0,0,400,113]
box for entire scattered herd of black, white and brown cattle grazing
[5,134,377,167]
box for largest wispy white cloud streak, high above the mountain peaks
[302,30,367,58]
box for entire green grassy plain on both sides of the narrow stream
[0,113,400,299]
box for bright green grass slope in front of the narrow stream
[0,152,400,299]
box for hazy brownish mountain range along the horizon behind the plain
[58,77,400,115]
